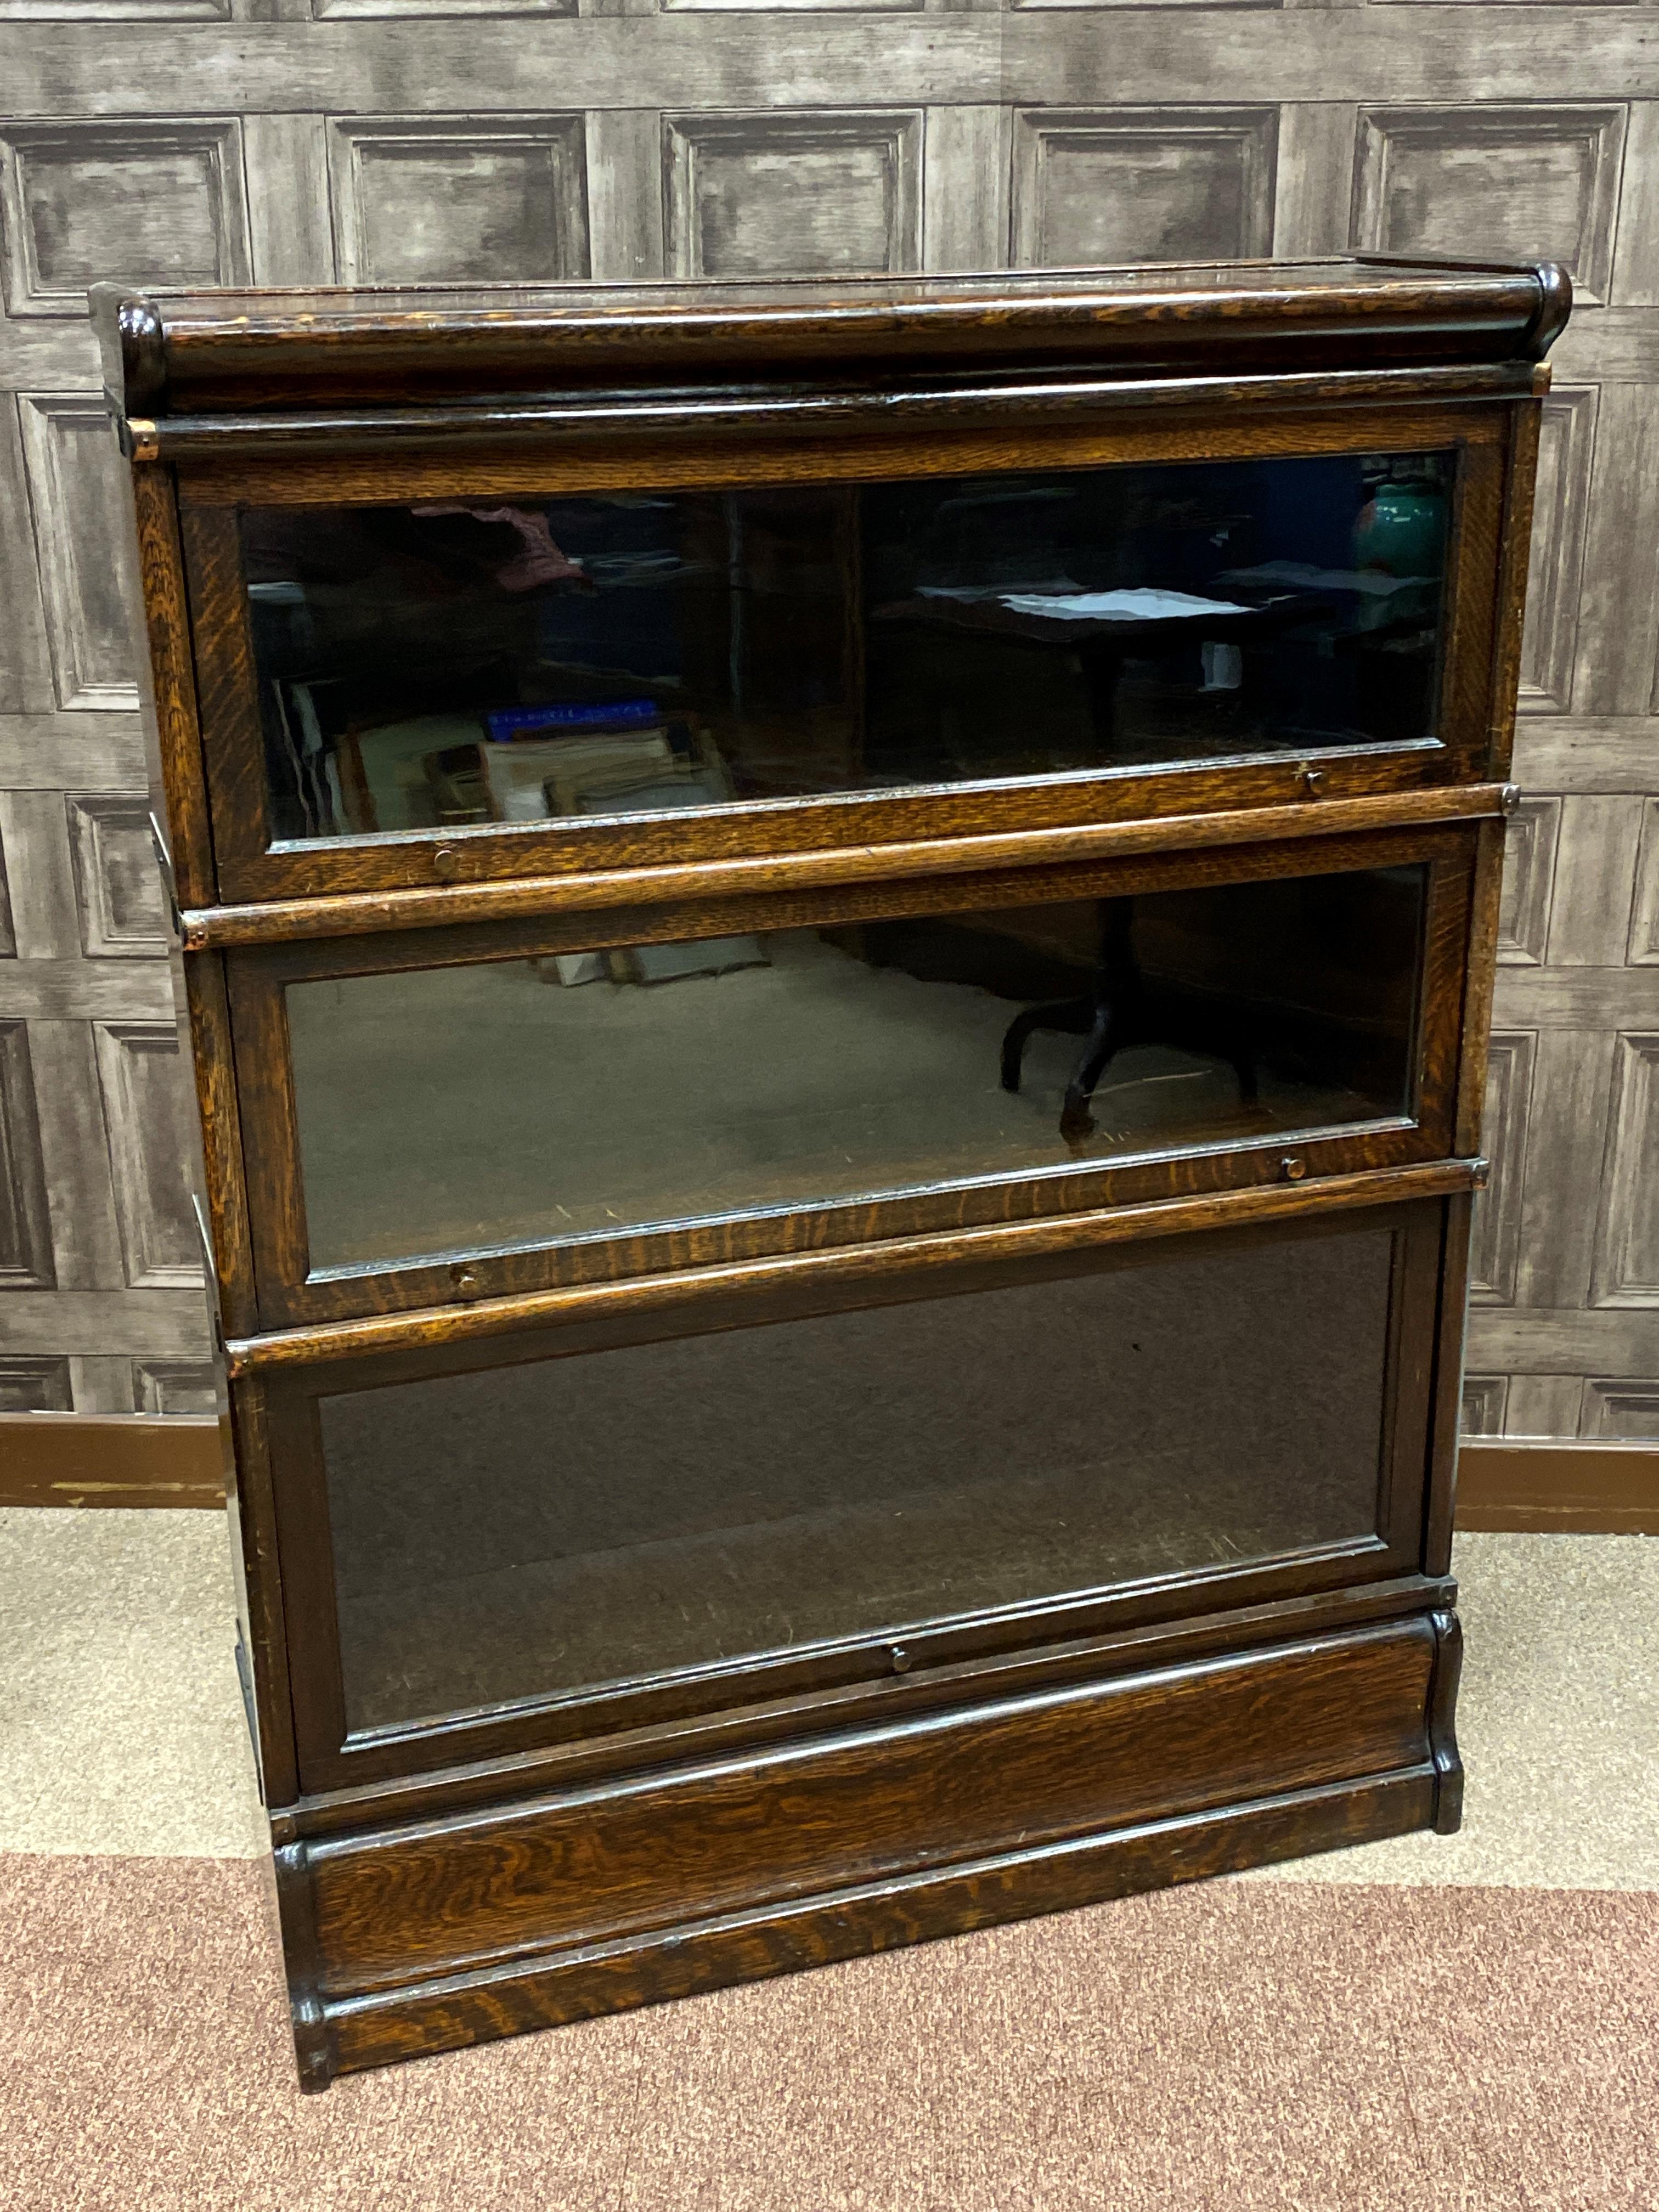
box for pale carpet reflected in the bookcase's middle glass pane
[287,933,1400,1267]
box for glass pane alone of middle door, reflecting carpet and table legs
[287,867,1425,1267]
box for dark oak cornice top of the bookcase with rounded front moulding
[93,257,1571,418]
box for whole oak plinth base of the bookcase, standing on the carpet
[276,1612,1460,2090]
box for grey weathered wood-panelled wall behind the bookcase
[0,0,1659,1438]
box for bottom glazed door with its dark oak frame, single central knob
[256,1201,1440,1772]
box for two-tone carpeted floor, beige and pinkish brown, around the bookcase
[0,1513,1659,2212]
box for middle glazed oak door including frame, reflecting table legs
[228,825,1473,1327]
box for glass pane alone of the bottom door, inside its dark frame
[321,1228,1393,1730]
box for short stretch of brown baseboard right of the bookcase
[1458,1438,1659,1535]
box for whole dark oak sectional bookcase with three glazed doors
[95,259,1568,2088]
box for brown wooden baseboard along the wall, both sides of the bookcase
[0,1413,1659,1535]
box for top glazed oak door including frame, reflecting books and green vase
[184,418,1500,898]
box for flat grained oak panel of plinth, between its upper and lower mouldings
[312,1621,1434,1995]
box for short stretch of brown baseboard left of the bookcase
[0,1413,225,1506]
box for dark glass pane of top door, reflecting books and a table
[241,454,1451,838]
